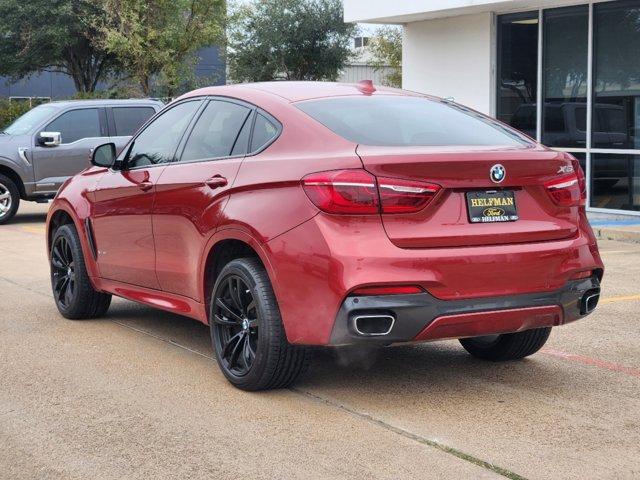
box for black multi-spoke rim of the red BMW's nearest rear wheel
[212,275,259,377]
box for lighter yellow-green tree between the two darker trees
[101,0,226,96]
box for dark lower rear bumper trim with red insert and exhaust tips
[330,277,600,345]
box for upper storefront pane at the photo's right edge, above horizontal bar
[591,0,640,149]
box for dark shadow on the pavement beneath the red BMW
[105,299,572,396]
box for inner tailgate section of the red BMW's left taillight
[378,177,440,213]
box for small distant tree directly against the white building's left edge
[369,26,402,88]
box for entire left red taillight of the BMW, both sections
[302,169,440,215]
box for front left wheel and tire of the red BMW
[50,224,111,320]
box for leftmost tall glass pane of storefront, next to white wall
[497,12,538,138]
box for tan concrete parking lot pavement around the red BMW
[0,204,640,479]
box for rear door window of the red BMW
[180,100,251,162]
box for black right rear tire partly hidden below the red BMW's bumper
[460,327,551,362]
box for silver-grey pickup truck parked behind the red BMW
[0,100,163,224]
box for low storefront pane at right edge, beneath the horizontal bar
[591,153,640,211]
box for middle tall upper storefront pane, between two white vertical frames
[542,5,589,148]
